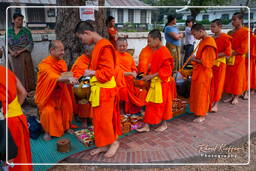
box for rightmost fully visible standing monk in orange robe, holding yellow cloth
[224,12,248,105]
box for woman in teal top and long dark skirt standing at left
[7,13,36,92]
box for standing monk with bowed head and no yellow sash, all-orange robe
[190,24,217,122]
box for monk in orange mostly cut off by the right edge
[250,31,256,94]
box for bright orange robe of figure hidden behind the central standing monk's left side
[138,45,154,75]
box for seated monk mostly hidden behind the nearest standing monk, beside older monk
[71,46,94,128]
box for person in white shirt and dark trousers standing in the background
[183,19,195,63]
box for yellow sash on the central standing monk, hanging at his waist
[146,76,163,103]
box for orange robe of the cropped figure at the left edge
[0,65,33,171]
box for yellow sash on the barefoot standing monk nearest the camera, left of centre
[89,76,116,107]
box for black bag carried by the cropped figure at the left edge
[0,120,18,161]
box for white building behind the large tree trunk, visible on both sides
[0,0,151,30]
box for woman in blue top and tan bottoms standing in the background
[164,15,183,71]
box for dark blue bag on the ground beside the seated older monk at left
[27,116,43,139]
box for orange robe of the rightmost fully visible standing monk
[224,27,248,95]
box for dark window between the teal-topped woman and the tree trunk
[27,8,45,22]
